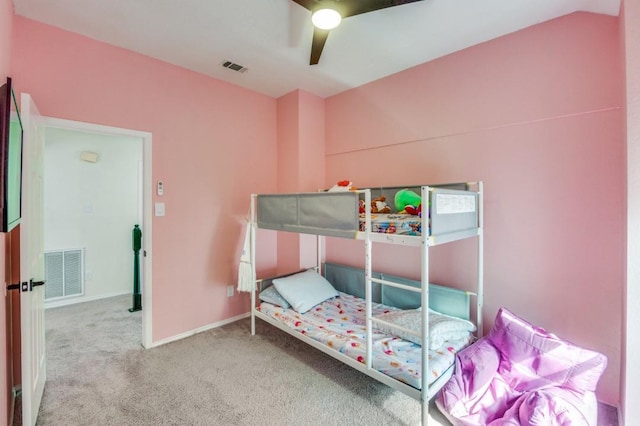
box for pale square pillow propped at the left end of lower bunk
[273,269,338,314]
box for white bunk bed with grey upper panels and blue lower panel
[250,182,483,425]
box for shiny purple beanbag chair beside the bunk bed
[436,308,607,426]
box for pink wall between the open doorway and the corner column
[12,17,276,341]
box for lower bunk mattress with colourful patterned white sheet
[258,293,473,389]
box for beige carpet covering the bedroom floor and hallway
[37,296,447,426]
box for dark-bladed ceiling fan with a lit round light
[293,0,422,65]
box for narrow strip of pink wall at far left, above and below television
[0,0,13,421]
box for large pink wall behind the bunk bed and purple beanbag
[326,13,625,405]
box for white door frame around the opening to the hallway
[43,116,153,348]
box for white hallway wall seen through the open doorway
[44,128,142,302]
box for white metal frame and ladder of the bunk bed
[250,181,484,425]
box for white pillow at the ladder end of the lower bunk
[375,309,476,349]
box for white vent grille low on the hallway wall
[44,249,84,300]
